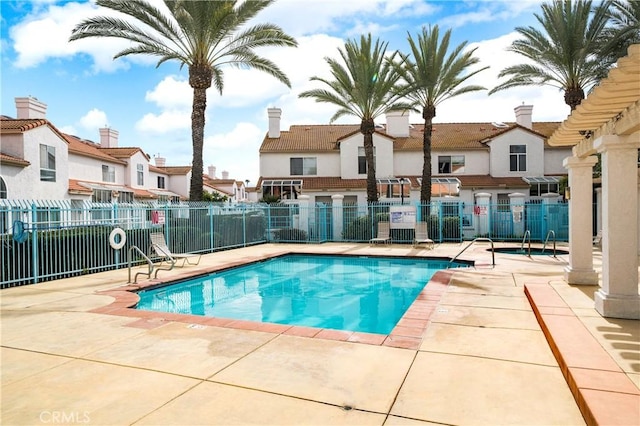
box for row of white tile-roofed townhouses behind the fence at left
[0,97,247,210]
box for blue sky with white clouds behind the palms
[0,0,569,185]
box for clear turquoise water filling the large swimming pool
[137,255,466,334]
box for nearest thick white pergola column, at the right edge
[594,133,640,319]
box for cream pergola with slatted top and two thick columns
[549,44,640,319]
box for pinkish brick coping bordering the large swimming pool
[90,251,460,349]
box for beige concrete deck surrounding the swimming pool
[0,243,640,425]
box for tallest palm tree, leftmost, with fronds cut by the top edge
[69,0,297,201]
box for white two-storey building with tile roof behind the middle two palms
[257,105,571,204]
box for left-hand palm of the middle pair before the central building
[299,34,409,203]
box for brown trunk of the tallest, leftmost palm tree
[189,65,212,201]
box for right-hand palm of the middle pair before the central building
[395,25,489,204]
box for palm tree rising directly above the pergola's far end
[489,0,609,111]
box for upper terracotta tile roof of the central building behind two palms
[260,122,560,153]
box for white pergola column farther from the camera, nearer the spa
[562,156,598,285]
